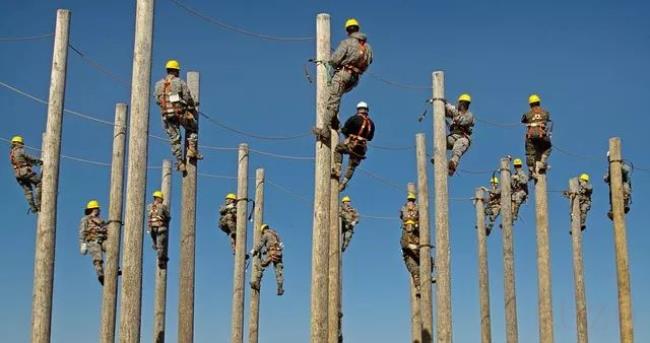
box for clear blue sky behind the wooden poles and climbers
[0,0,650,343]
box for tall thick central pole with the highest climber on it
[311,13,331,343]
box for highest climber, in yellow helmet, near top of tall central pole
[313,18,373,142]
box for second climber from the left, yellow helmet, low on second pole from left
[79,200,108,286]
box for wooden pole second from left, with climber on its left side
[100,103,127,343]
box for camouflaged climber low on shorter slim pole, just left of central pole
[250,224,284,295]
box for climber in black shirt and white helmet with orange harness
[332,101,375,191]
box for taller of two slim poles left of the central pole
[230,143,248,343]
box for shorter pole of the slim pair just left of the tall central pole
[248,168,265,343]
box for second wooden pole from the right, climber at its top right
[569,177,588,343]
